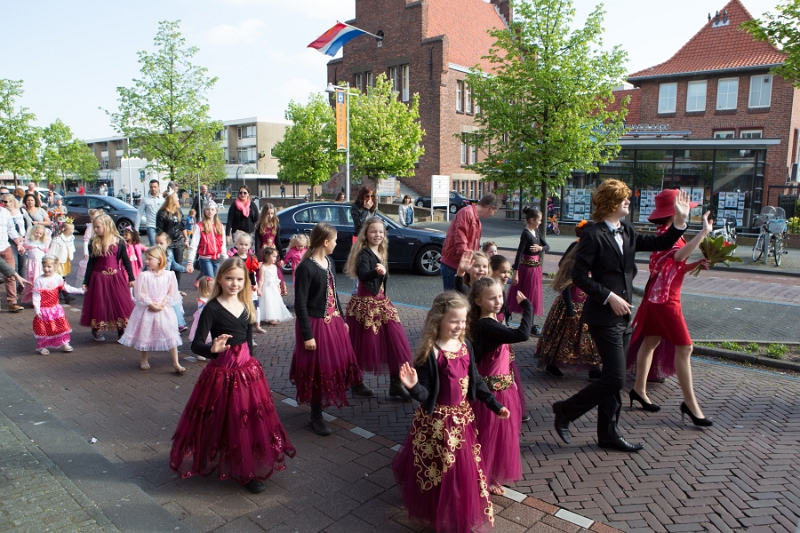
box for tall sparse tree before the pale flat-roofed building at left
[108,21,224,181]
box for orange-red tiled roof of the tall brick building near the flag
[425,0,505,70]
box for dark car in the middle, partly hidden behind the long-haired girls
[278,202,445,276]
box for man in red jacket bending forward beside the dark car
[440,192,500,291]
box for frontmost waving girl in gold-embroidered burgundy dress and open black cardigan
[392,291,518,533]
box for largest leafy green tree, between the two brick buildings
[465,0,627,212]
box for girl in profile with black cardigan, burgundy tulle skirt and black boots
[289,222,360,436]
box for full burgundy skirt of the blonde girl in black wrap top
[169,343,296,485]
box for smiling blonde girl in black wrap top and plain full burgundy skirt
[169,257,296,493]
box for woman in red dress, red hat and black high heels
[627,189,712,426]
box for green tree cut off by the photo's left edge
[0,79,39,185]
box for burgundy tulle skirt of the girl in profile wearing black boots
[289,315,362,407]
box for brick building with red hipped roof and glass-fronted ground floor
[562,0,800,227]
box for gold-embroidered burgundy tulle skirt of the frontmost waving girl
[392,401,494,533]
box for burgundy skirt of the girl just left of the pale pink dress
[81,269,133,331]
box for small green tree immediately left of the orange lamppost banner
[272,94,345,200]
